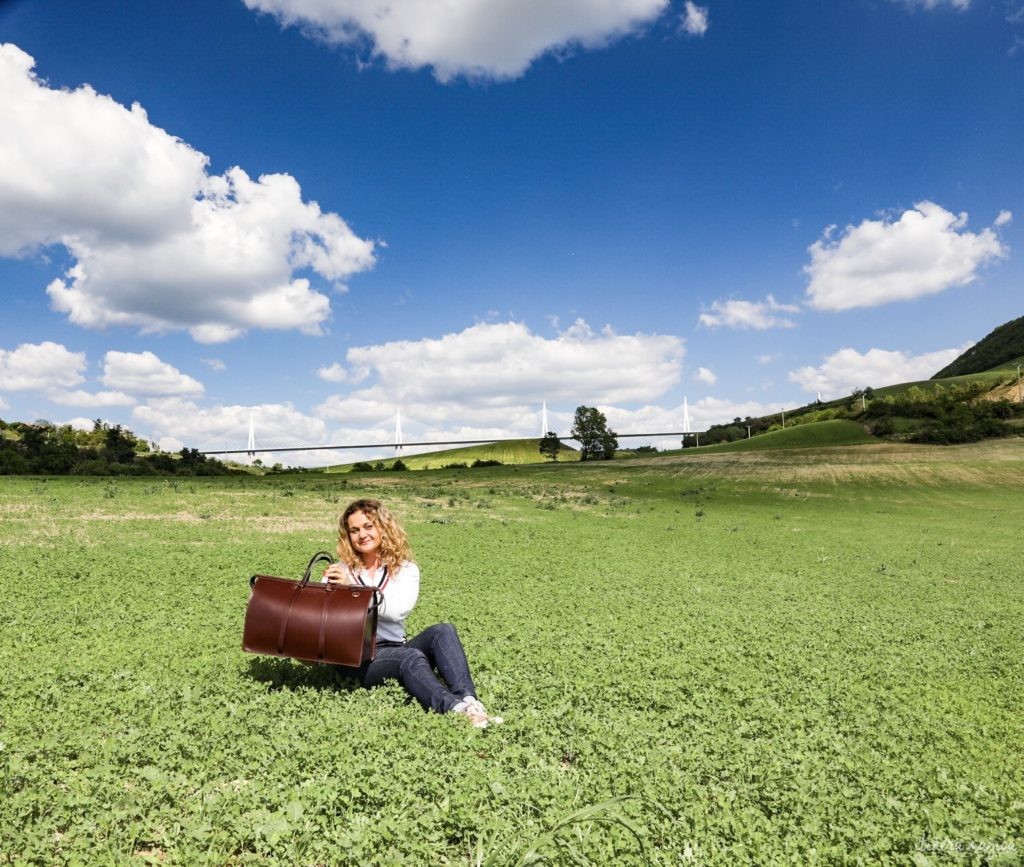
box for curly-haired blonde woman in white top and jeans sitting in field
[324,500,502,729]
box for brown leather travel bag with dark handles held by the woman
[242,551,387,666]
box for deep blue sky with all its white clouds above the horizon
[0,0,1024,464]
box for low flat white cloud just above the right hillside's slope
[790,343,972,400]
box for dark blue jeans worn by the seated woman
[362,623,476,713]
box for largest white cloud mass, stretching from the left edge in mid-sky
[0,44,374,343]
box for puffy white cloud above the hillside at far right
[804,202,1007,310]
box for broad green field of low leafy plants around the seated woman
[0,440,1024,865]
